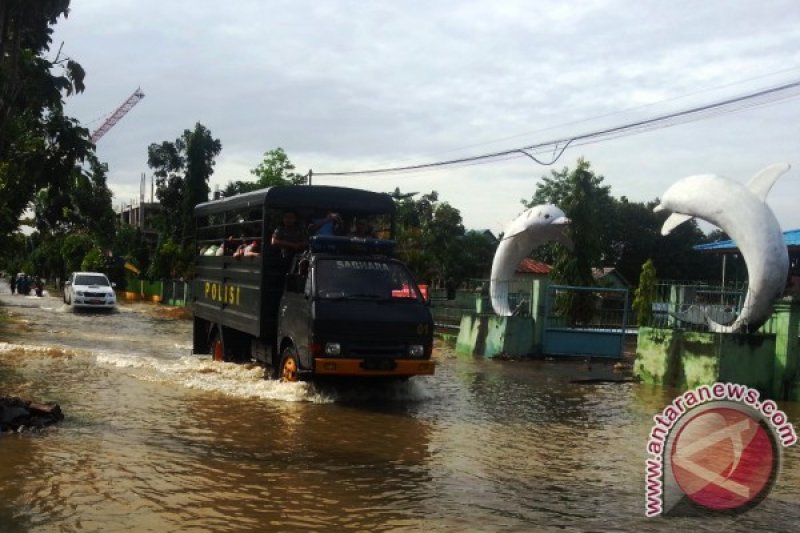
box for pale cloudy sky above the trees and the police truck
[53,0,800,231]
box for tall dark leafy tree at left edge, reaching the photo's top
[0,0,93,234]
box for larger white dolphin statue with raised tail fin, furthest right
[654,163,790,333]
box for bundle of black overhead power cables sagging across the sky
[314,80,800,176]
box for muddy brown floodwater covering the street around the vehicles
[0,286,800,532]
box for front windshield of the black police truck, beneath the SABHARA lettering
[316,259,422,301]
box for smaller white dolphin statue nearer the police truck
[489,204,571,316]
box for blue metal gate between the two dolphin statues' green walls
[542,285,628,358]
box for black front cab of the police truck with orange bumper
[278,236,434,381]
